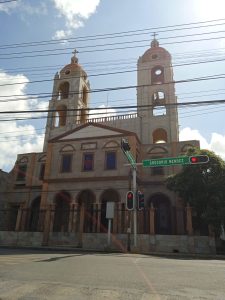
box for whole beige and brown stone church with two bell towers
[0,39,214,252]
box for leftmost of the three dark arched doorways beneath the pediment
[53,191,71,232]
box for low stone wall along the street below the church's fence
[0,231,216,254]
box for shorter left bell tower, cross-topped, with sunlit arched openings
[44,50,90,151]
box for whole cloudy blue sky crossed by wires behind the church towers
[0,0,225,171]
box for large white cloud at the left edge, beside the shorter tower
[0,70,46,171]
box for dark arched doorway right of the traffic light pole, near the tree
[149,193,171,234]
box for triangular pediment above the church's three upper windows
[52,123,134,142]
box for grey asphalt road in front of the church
[0,249,225,300]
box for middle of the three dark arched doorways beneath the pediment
[77,190,97,233]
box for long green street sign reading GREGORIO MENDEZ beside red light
[142,156,190,167]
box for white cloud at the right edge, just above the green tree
[180,127,225,159]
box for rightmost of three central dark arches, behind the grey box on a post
[100,189,119,232]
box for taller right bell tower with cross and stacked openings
[137,34,178,144]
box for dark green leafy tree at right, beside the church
[167,148,225,236]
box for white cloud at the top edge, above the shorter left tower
[52,0,100,37]
